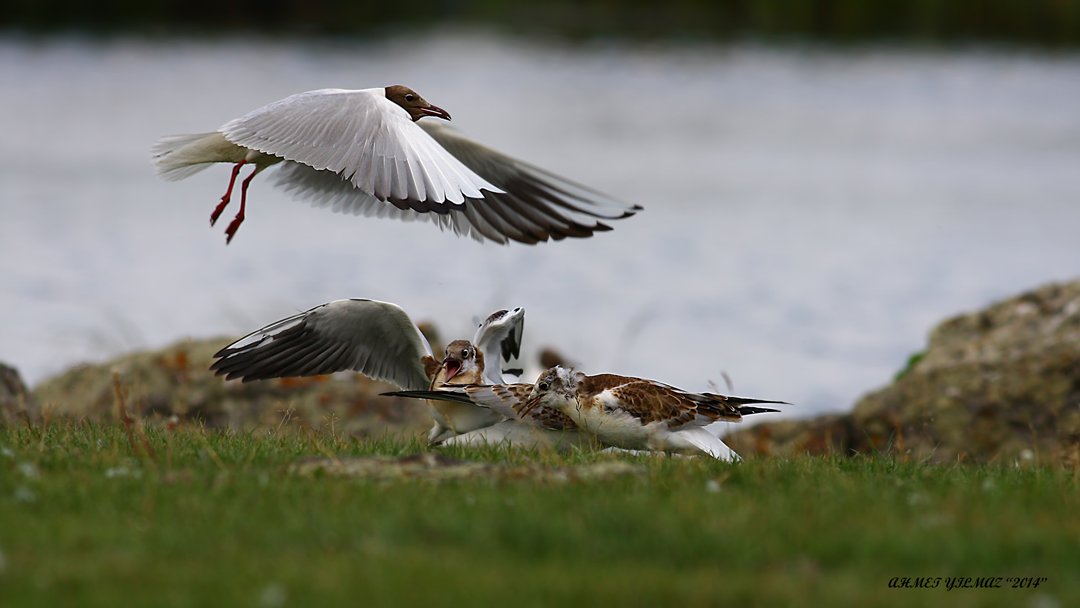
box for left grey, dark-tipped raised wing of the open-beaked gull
[211,299,432,390]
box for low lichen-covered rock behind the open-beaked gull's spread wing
[33,338,430,435]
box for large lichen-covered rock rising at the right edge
[729,281,1080,462]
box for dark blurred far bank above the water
[6,0,1080,46]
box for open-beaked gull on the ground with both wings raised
[211,299,525,444]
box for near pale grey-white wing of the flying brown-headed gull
[219,89,498,207]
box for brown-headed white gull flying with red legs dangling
[153,85,642,244]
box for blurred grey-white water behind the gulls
[0,22,1080,416]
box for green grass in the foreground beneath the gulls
[0,424,1080,608]
